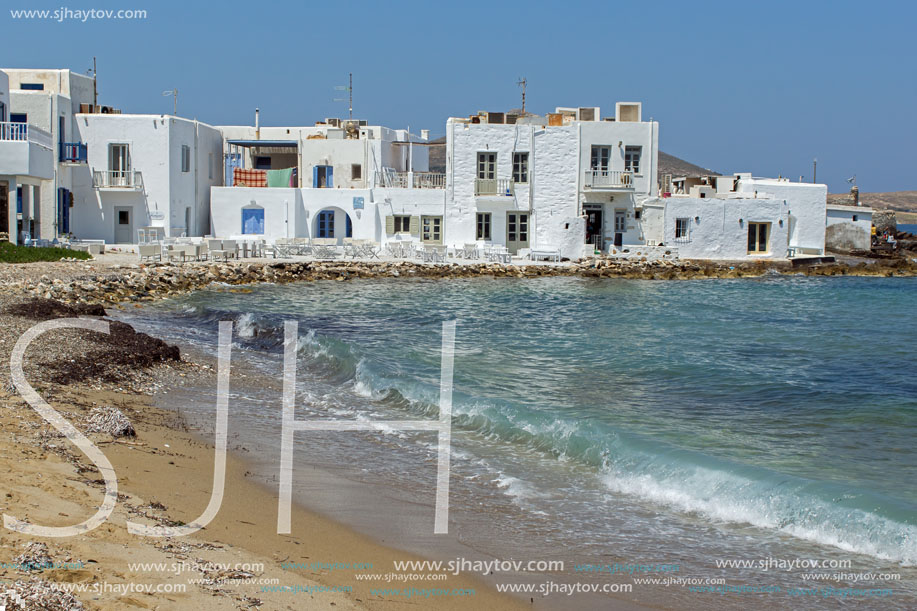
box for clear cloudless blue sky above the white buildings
[0,0,917,192]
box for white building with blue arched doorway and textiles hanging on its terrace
[210,118,445,243]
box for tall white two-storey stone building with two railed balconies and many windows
[445,103,659,259]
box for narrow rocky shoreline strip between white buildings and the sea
[7,258,917,304]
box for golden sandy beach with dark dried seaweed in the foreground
[0,263,531,609]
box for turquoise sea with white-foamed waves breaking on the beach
[116,275,917,608]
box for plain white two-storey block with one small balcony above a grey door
[71,113,223,244]
